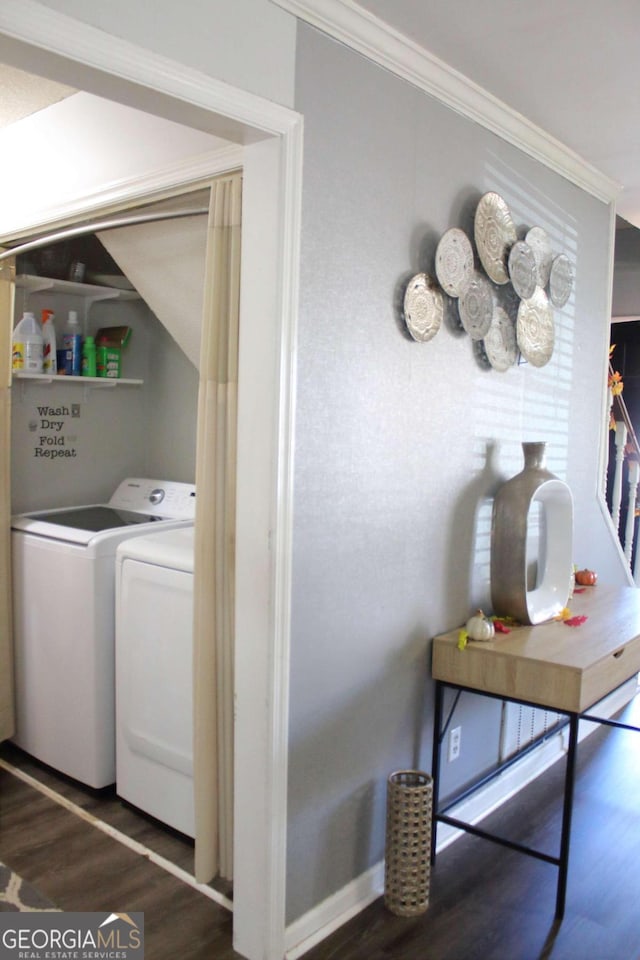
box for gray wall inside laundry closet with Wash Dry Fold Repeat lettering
[11,290,198,513]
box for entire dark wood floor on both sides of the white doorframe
[0,704,640,960]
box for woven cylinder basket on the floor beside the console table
[384,770,433,917]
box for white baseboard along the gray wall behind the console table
[285,677,638,960]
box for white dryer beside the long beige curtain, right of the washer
[116,527,195,837]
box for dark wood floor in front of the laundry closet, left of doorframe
[0,769,239,960]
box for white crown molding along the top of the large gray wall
[272,0,621,203]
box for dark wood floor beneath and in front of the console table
[305,702,640,960]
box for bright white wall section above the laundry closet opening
[0,92,229,236]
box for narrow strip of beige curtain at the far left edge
[0,258,15,741]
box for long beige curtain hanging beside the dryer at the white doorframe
[194,174,242,883]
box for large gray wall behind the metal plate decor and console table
[287,20,624,921]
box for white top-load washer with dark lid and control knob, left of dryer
[11,478,195,787]
